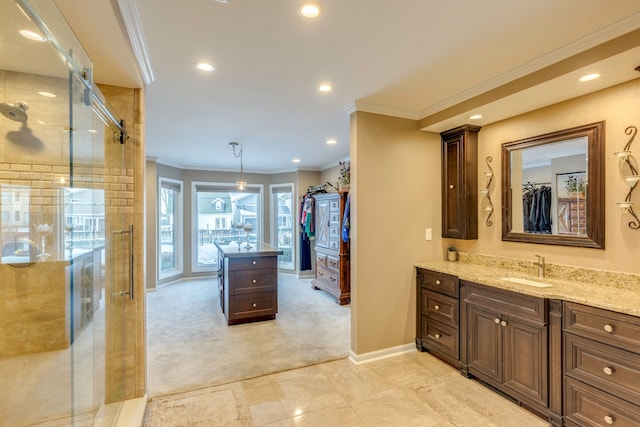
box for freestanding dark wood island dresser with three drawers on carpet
[216,243,283,325]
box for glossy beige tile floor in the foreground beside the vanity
[146,351,549,427]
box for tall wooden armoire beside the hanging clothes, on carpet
[311,193,351,305]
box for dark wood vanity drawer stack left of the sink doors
[416,268,460,368]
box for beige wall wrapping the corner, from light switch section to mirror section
[351,79,640,355]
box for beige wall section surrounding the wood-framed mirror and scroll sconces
[460,79,640,273]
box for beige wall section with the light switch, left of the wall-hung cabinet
[351,112,441,354]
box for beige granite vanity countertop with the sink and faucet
[415,261,640,317]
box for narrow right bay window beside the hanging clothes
[271,184,296,270]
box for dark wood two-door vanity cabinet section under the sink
[460,280,561,425]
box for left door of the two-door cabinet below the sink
[467,304,503,382]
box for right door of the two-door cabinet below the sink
[501,319,548,406]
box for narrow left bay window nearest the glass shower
[158,177,183,279]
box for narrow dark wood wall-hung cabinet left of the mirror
[440,125,480,239]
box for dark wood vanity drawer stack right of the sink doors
[563,302,640,426]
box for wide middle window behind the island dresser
[191,182,263,272]
